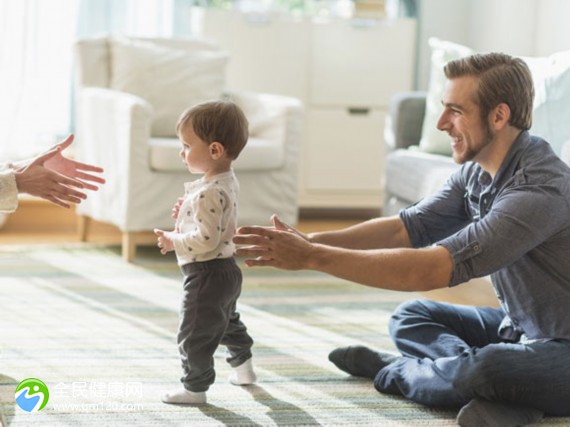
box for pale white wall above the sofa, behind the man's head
[416,0,570,89]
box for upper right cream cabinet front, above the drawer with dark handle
[309,20,415,107]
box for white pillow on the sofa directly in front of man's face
[419,37,474,156]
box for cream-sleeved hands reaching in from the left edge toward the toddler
[0,135,105,212]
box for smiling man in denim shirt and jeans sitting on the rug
[234,53,570,426]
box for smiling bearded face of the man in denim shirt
[437,76,495,164]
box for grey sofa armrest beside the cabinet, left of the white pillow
[384,92,426,151]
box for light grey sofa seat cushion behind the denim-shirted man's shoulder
[386,147,459,203]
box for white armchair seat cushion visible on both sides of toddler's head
[149,137,285,172]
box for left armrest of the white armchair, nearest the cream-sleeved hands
[77,87,152,228]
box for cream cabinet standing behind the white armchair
[196,9,416,209]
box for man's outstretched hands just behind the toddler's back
[233,215,315,270]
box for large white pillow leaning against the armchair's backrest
[110,37,229,137]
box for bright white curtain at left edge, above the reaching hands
[0,0,80,161]
